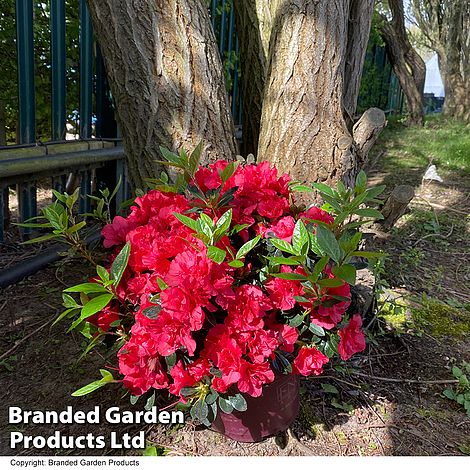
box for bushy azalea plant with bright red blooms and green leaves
[25,145,384,425]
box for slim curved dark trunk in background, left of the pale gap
[380,0,426,126]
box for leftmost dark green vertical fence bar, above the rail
[16,0,36,144]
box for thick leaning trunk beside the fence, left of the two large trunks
[88,0,236,188]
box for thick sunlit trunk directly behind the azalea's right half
[258,0,383,189]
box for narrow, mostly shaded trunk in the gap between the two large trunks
[235,0,281,156]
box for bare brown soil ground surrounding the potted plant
[0,140,470,456]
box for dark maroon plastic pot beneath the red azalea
[212,374,299,442]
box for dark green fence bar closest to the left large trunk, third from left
[80,0,93,139]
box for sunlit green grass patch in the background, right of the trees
[378,115,470,174]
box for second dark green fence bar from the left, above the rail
[51,0,66,140]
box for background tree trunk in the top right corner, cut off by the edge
[412,0,470,123]
